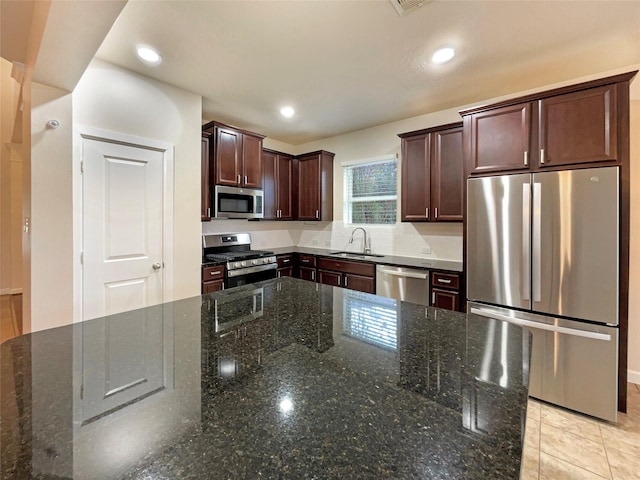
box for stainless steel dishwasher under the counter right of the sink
[376,265,429,305]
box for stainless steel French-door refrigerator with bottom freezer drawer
[466,167,620,421]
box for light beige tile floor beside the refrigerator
[520,383,640,480]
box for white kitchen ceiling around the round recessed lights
[48,0,640,145]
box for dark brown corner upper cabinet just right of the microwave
[262,149,293,220]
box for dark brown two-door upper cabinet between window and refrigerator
[399,123,464,222]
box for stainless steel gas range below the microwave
[202,233,278,288]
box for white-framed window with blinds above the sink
[343,156,398,224]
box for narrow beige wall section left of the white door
[31,83,73,331]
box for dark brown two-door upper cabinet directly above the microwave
[203,122,264,188]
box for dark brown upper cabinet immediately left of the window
[296,150,335,222]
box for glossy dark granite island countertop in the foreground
[0,278,530,479]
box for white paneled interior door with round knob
[82,138,165,320]
